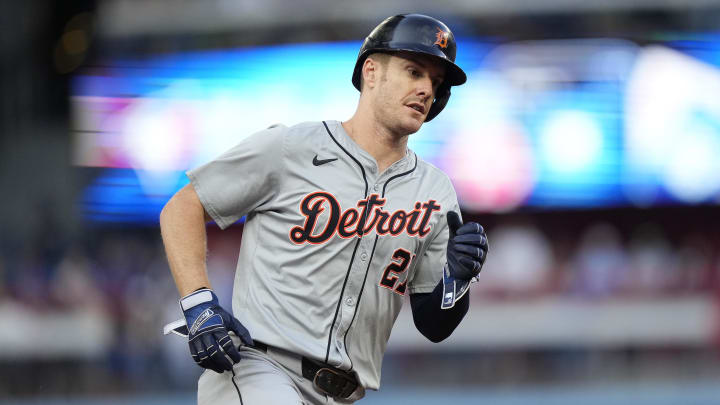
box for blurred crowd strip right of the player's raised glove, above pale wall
[475,216,720,299]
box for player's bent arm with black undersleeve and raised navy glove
[410,211,488,343]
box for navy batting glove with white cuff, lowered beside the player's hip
[180,288,253,373]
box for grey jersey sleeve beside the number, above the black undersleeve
[408,178,460,294]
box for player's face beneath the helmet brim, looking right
[375,53,445,135]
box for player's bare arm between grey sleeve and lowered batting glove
[160,185,210,297]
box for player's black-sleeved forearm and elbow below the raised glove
[410,281,470,343]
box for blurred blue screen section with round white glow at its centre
[526,82,623,207]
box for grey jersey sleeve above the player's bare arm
[186,126,287,229]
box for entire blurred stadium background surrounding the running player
[0,0,720,404]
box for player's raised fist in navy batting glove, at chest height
[447,211,488,280]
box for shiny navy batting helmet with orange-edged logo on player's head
[352,14,467,122]
